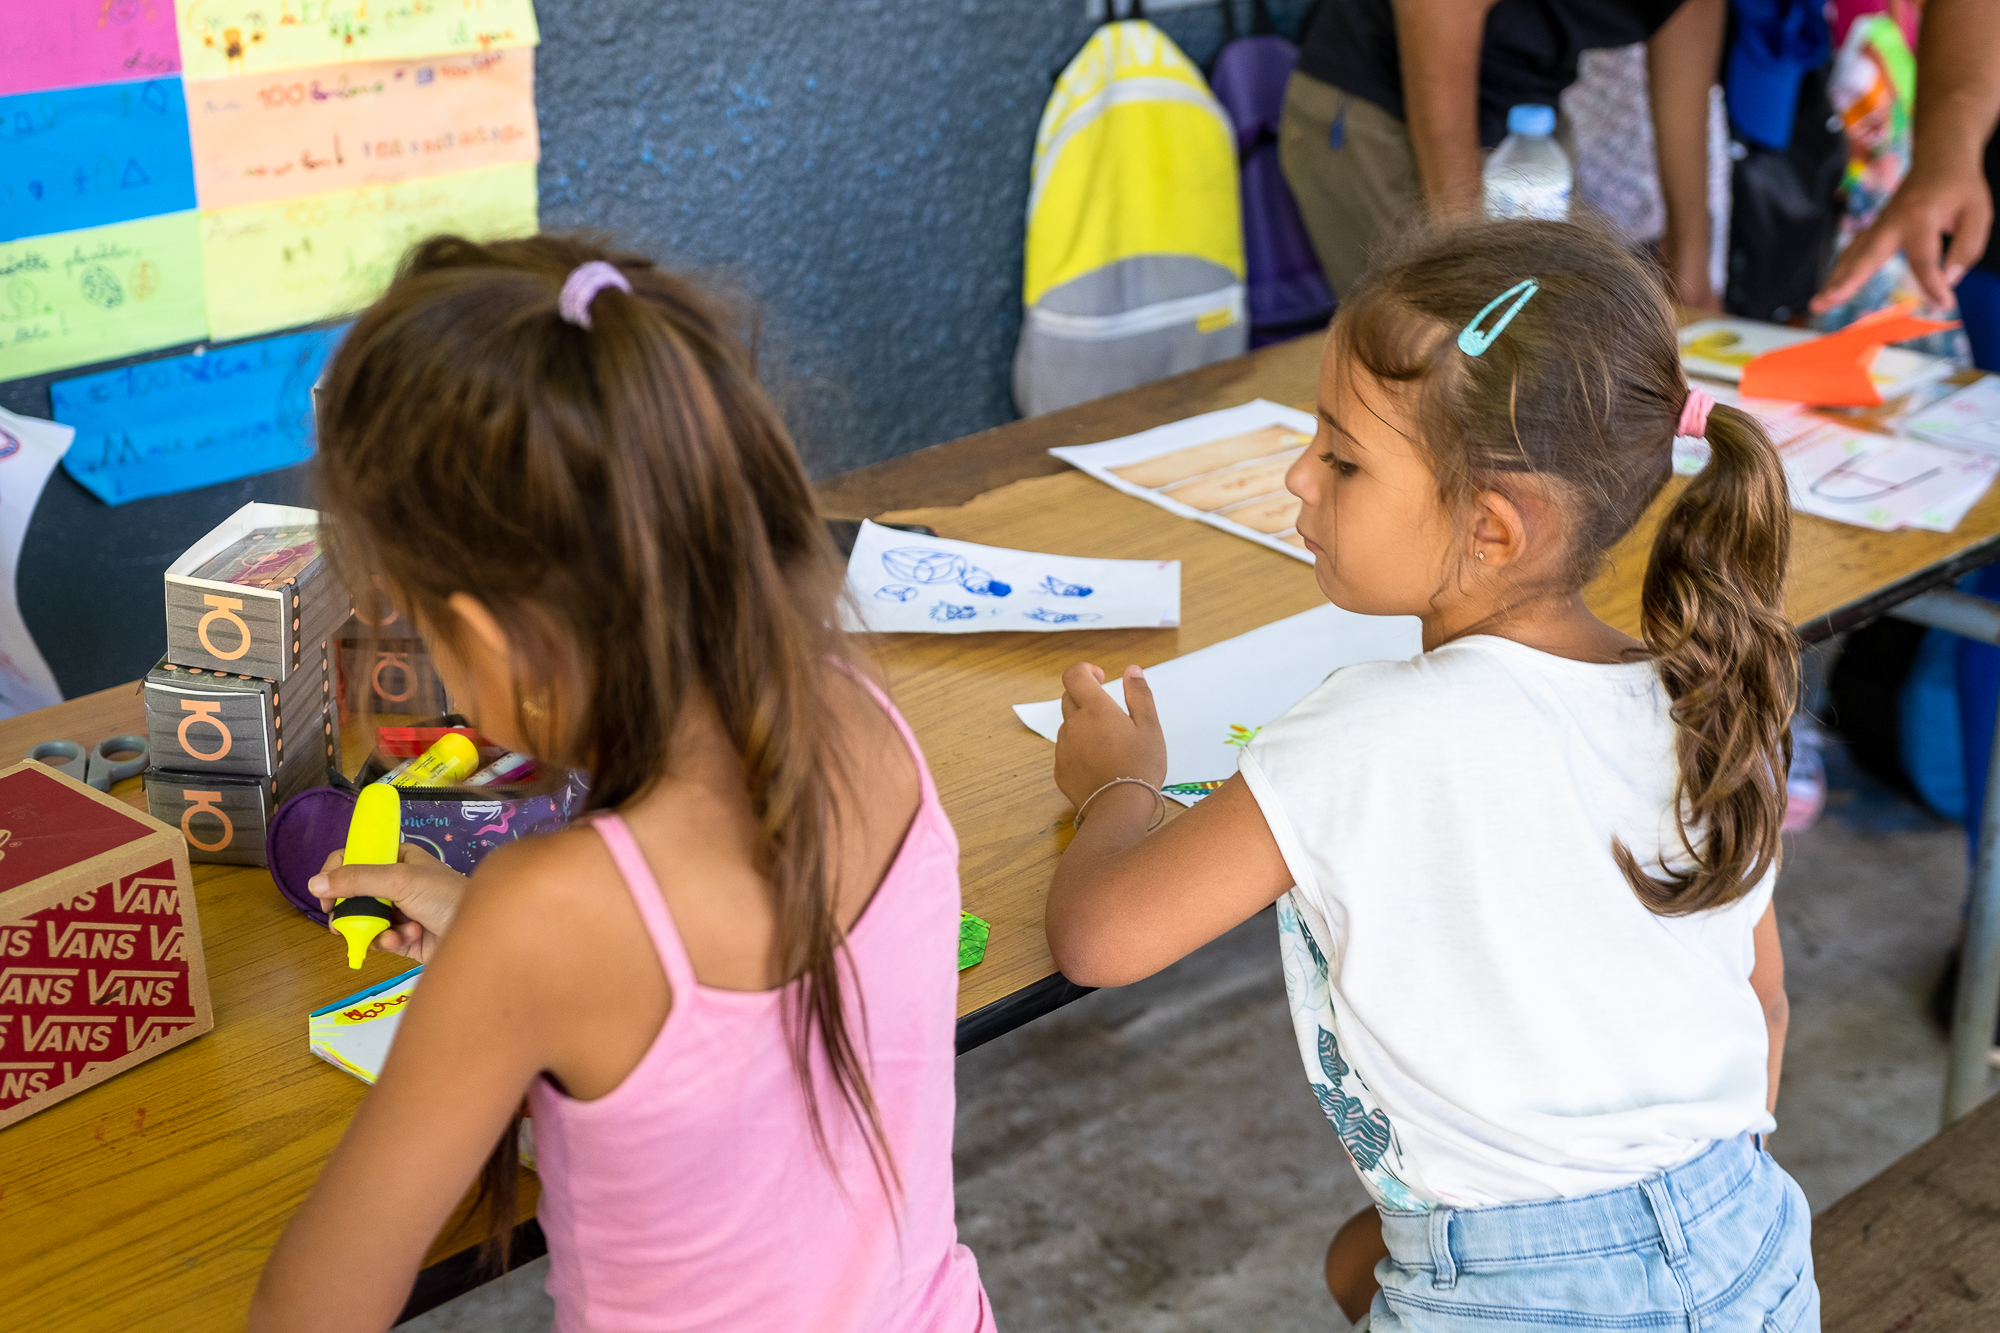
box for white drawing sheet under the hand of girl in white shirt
[1014,606,1424,805]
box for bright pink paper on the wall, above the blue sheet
[0,0,180,96]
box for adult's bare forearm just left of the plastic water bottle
[1394,0,1498,216]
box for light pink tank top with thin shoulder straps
[528,685,992,1333]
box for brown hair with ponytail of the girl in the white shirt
[1332,220,1798,917]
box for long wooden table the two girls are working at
[11,340,2000,1333]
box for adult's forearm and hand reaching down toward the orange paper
[1812,0,2000,310]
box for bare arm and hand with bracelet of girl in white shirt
[1048,662,1292,987]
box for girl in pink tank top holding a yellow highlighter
[250,236,992,1333]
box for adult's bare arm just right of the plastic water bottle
[1646,0,1726,310]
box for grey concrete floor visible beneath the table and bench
[402,728,1966,1333]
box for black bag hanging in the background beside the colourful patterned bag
[1722,70,1848,324]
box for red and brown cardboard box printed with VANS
[0,761,216,1129]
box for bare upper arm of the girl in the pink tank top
[250,849,592,1333]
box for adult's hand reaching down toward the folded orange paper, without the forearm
[1812,156,1994,310]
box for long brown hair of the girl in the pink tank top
[318,236,896,1263]
